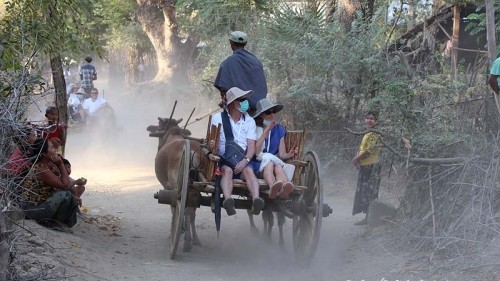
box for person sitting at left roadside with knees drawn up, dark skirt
[22,139,81,232]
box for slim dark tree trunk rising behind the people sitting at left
[50,54,68,156]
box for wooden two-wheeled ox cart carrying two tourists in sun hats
[148,102,332,264]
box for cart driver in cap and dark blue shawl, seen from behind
[214,31,267,111]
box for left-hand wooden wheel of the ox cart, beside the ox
[170,140,191,259]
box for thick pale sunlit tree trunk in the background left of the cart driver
[137,0,199,81]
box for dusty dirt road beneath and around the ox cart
[17,82,410,281]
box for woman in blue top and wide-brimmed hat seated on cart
[253,99,298,199]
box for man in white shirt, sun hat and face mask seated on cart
[211,87,264,216]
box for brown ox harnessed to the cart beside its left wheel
[147,117,201,251]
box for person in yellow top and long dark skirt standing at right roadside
[352,111,382,225]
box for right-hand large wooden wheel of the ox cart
[293,151,323,265]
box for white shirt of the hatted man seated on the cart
[212,109,257,155]
